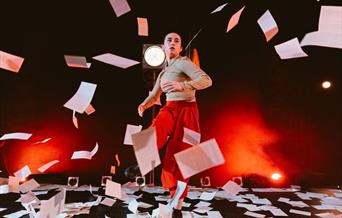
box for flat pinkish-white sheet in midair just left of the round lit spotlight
[93,53,140,69]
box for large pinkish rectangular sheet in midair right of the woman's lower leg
[175,139,224,178]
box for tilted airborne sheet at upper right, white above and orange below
[258,10,278,42]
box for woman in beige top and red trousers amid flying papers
[138,32,212,217]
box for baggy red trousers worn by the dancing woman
[151,101,200,199]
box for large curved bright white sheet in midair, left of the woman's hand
[64,82,97,114]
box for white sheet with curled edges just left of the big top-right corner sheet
[274,38,308,59]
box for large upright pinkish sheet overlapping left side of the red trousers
[132,127,160,176]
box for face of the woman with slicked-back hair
[164,33,183,58]
